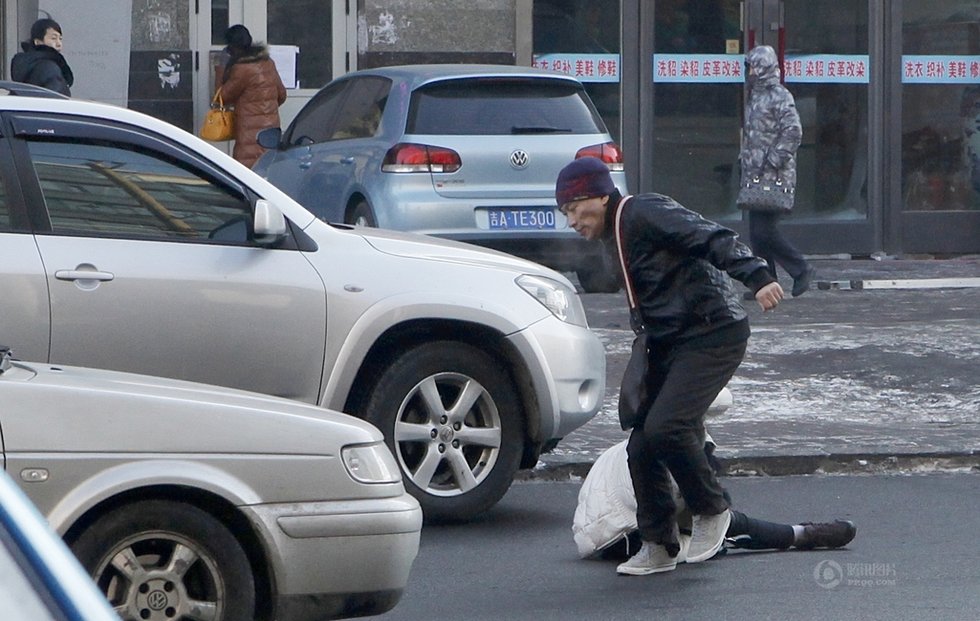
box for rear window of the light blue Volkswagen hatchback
[407,78,606,135]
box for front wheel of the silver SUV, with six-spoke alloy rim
[364,341,524,522]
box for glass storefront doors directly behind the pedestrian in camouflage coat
[650,0,874,252]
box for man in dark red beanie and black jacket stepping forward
[555,158,783,575]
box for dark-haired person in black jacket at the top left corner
[10,19,75,97]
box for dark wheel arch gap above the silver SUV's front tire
[344,319,542,468]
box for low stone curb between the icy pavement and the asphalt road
[514,450,980,482]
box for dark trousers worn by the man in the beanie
[626,341,746,555]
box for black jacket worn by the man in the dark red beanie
[603,194,773,344]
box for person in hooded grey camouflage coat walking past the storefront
[739,45,815,297]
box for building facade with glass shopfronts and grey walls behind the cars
[0,0,980,255]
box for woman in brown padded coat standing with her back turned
[220,24,286,167]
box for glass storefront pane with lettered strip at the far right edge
[894,0,980,253]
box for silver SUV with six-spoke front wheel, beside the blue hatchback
[0,83,605,519]
